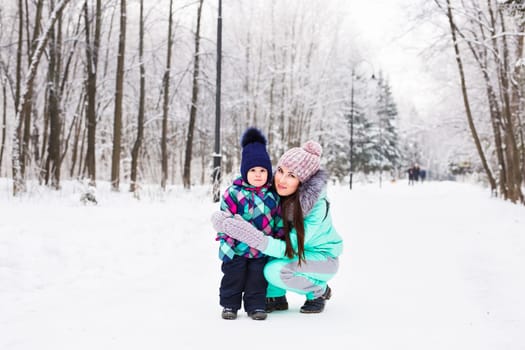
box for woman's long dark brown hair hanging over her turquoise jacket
[281,190,305,265]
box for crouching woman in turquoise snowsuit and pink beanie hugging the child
[212,141,343,313]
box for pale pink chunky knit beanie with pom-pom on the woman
[277,141,323,182]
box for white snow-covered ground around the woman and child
[0,180,525,350]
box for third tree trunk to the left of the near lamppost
[129,0,146,192]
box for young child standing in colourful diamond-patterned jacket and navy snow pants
[216,128,284,320]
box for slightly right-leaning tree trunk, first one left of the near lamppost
[182,0,203,189]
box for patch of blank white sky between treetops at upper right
[345,0,452,119]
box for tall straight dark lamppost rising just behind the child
[212,0,222,203]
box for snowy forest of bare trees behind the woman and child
[0,0,525,203]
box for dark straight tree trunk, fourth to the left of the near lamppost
[111,0,126,191]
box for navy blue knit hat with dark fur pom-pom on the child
[241,127,272,183]
